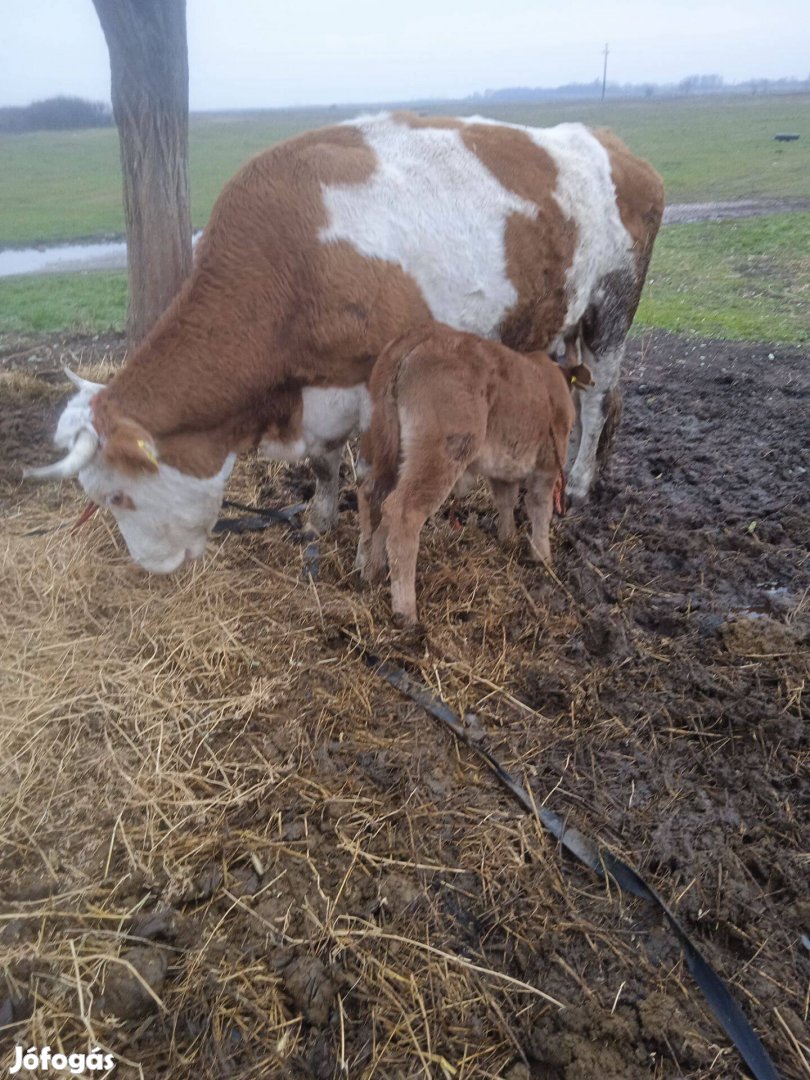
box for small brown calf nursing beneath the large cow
[359,323,591,624]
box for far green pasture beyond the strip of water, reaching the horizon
[0,95,810,247]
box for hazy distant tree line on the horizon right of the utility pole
[467,75,810,103]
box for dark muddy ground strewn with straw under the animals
[0,334,810,1080]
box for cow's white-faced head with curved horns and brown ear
[26,372,235,573]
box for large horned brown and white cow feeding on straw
[30,113,663,572]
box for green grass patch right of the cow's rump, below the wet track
[635,214,810,345]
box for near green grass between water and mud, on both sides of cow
[0,214,810,345]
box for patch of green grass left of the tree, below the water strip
[0,270,126,335]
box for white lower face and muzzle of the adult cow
[79,454,237,573]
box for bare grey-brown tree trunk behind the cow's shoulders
[93,0,191,348]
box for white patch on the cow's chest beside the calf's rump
[259,382,372,461]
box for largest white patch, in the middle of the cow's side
[320,113,538,337]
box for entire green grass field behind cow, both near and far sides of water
[0,96,810,343]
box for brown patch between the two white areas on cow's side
[461,124,577,352]
